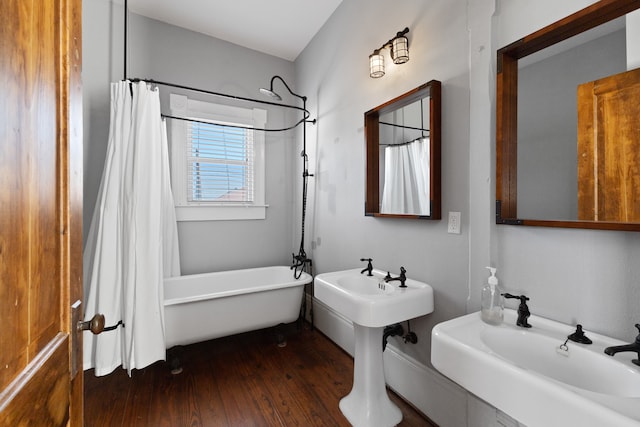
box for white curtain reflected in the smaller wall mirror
[380,138,431,215]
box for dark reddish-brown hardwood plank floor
[85,325,435,427]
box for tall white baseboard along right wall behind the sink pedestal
[313,299,467,427]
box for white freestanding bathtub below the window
[164,266,312,349]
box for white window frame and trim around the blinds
[169,93,268,221]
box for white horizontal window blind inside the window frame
[186,122,254,203]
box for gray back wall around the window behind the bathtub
[83,0,301,274]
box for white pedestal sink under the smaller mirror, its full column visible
[315,269,433,427]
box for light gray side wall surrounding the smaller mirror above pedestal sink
[296,0,470,364]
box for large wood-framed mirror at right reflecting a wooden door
[496,0,640,231]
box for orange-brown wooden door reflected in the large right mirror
[578,69,640,222]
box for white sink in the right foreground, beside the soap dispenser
[431,310,640,427]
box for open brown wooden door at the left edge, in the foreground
[0,0,83,426]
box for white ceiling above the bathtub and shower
[127,0,342,61]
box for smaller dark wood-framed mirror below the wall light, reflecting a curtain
[364,80,442,220]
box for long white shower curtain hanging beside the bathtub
[83,81,180,375]
